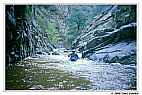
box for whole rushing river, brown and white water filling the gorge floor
[6,55,136,90]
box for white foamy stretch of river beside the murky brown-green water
[29,55,136,90]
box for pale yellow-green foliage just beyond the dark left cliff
[36,6,60,45]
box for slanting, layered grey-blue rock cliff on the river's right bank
[73,5,137,64]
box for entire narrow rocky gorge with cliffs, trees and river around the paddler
[5,5,137,91]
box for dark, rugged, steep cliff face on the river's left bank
[6,5,53,64]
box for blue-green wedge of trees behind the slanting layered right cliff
[66,5,111,45]
